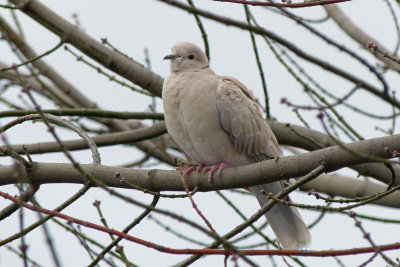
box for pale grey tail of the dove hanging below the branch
[249,182,311,249]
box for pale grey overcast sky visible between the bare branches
[0,0,400,266]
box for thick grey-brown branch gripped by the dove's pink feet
[0,135,400,191]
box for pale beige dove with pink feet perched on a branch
[162,42,311,249]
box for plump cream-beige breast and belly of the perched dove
[163,70,244,165]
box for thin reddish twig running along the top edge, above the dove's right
[214,0,351,8]
